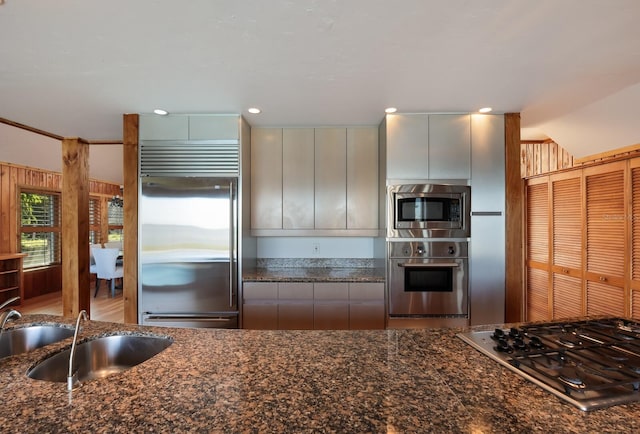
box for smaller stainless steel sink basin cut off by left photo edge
[0,325,73,358]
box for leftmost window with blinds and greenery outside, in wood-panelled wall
[20,191,61,268]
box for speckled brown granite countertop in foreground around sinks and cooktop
[0,315,640,433]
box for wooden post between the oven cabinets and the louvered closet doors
[504,113,525,322]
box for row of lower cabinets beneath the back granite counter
[242,282,385,330]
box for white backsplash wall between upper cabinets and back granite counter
[258,237,375,258]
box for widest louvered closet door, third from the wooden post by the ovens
[585,162,627,315]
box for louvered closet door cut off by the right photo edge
[629,158,640,319]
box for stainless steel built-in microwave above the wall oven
[387,184,471,238]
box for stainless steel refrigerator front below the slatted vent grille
[138,177,238,328]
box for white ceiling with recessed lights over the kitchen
[0,0,640,176]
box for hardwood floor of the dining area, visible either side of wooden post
[18,284,124,323]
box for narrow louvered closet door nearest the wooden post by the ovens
[526,177,550,321]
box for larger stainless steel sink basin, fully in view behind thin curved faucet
[27,335,173,383]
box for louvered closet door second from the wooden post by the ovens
[551,171,583,319]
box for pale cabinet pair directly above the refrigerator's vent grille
[139,114,240,140]
